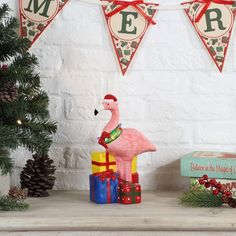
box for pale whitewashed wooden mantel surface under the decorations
[0,191,236,235]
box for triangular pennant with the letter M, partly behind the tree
[19,0,68,45]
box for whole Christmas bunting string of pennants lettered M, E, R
[19,0,236,75]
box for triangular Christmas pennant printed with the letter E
[102,0,158,75]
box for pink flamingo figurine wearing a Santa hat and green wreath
[94,94,156,181]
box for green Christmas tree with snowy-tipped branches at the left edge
[0,4,57,173]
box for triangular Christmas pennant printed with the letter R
[182,0,235,72]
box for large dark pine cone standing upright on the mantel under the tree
[20,154,56,197]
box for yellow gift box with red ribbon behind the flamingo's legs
[91,152,137,174]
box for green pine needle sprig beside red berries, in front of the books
[179,189,223,207]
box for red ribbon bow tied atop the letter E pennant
[106,0,156,25]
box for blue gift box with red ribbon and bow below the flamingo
[89,171,118,204]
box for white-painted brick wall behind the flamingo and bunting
[3,0,236,189]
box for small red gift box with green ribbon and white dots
[118,181,141,204]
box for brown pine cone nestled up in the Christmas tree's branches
[0,81,18,103]
